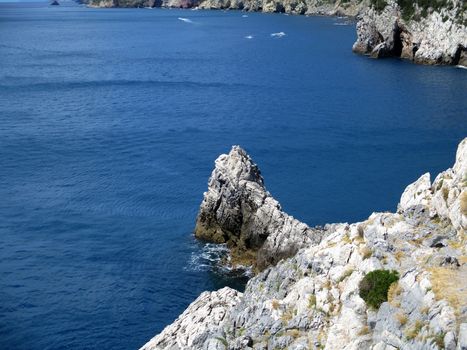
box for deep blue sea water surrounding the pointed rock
[0,2,467,350]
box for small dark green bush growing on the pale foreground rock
[359,270,399,309]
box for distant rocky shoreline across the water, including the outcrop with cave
[82,0,467,66]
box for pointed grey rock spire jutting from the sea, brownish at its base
[195,146,322,270]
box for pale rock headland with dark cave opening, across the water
[353,0,467,65]
